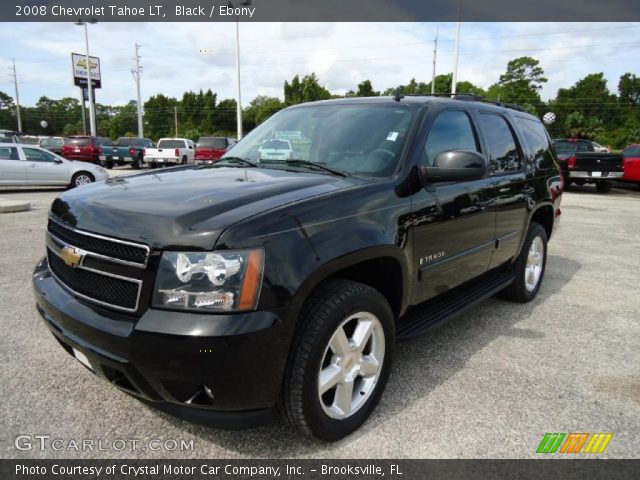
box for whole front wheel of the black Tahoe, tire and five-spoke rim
[282,280,395,441]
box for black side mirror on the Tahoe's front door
[418,150,489,185]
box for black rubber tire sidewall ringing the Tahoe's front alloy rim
[303,291,395,440]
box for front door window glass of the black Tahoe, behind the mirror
[423,110,478,165]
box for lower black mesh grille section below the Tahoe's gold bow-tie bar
[49,253,140,311]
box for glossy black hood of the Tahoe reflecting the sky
[51,166,363,249]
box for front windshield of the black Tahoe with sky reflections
[223,103,413,177]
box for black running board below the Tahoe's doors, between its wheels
[396,268,514,342]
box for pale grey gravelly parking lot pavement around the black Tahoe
[0,169,640,458]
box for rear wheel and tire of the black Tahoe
[501,222,547,303]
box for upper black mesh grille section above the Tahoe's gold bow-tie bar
[49,220,149,266]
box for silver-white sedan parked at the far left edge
[0,143,109,188]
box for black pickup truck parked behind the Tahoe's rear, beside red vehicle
[553,138,623,193]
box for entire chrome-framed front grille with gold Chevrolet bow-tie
[47,220,149,313]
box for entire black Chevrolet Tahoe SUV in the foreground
[33,95,562,440]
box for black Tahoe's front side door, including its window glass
[412,109,495,302]
